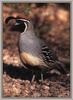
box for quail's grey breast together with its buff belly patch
[19,36,42,66]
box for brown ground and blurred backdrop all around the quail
[2,3,71,98]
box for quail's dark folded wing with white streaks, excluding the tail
[41,41,58,66]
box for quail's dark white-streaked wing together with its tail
[41,41,66,73]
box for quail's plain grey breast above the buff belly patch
[19,32,41,56]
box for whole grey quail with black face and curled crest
[5,16,66,80]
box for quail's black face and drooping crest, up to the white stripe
[5,17,27,33]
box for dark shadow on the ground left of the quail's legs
[3,63,33,80]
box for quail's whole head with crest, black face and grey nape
[5,16,32,33]
